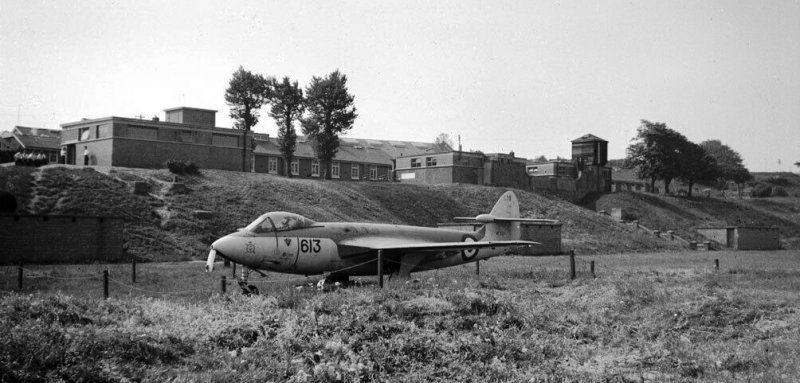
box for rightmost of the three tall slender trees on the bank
[300,69,358,179]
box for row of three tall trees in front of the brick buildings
[220,66,358,179]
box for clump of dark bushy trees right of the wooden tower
[624,120,753,197]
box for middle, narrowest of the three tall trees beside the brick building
[269,77,305,178]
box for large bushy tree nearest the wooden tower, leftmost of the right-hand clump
[625,120,688,193]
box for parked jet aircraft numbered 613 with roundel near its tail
[206,191,543,287]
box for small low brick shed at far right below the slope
[697,226,781,250]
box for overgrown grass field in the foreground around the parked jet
[0,251,800,382]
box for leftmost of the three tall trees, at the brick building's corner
[225,66,270,172]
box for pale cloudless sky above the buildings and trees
[0,0,800,171]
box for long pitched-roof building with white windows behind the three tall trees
[253,135,437,180]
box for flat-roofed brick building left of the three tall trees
[61,107,252,170]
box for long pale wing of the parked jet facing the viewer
[339,237,540,253]
